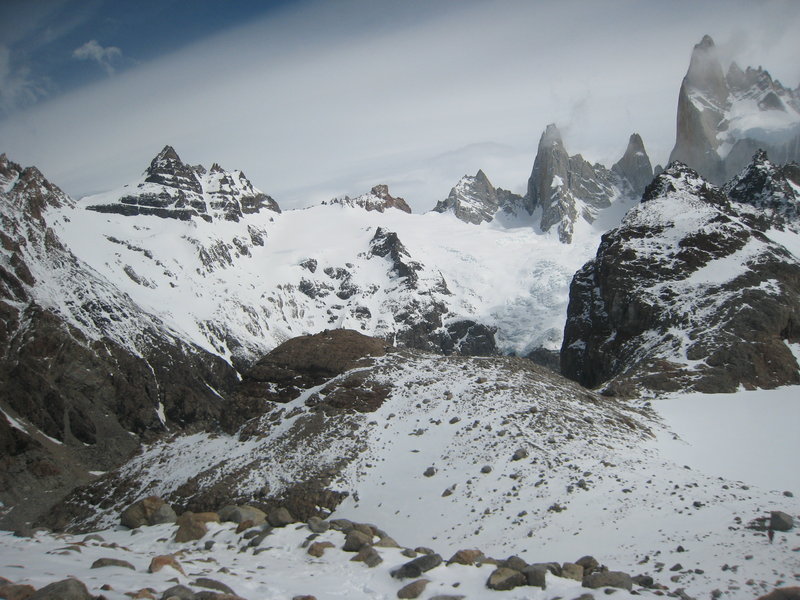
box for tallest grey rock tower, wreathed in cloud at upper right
[670,35,800,185]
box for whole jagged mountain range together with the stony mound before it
[0,36,800,600]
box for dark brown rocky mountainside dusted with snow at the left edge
[0,155,241,528]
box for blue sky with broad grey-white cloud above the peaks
[0,0,800,212]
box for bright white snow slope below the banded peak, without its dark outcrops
[57,198,620,362]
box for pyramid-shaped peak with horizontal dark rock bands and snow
[87,146,280,222]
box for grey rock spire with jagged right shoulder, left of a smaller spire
[525,124,617,244]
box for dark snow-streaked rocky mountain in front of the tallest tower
[561,157,800,393]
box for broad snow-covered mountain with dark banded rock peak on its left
[57,148,624,367]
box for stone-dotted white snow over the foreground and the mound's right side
[0,370,800,600]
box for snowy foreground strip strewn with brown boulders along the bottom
[0,496,800,600]
